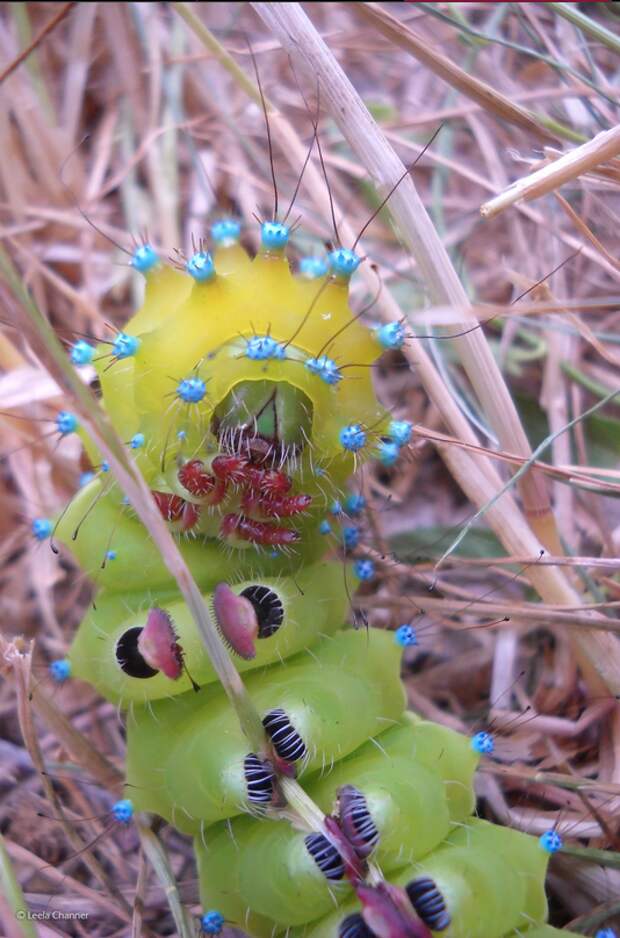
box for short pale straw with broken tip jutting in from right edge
[480,125,620,218]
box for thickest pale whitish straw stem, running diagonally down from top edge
[253,3,557,524]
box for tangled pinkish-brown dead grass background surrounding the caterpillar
[0,3,620,938]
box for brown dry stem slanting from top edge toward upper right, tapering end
[356,3,557,142]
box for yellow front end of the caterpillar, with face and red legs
[57,229,388,582]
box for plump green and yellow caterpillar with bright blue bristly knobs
[3,11,608,938]
